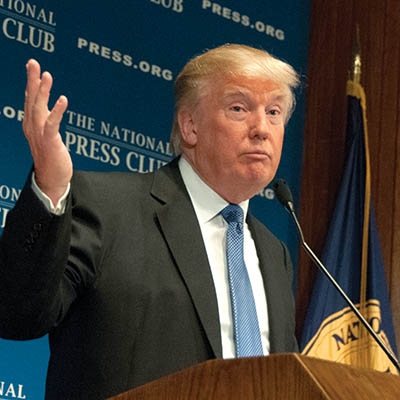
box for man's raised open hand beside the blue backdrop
[22,59,72,204]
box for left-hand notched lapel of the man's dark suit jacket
[152,161,222,357]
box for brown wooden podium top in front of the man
[107,353,400,400]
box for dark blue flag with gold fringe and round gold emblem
[300,81,398,374]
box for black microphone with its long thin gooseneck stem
[272,179,400,372]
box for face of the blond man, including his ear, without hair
[180,77,287,203]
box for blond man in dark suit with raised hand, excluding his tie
[0,45,297,399]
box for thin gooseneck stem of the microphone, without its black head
[284,201,400,372]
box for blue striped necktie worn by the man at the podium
[221,204,263,357]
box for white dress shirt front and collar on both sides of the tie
[179,157,269,358]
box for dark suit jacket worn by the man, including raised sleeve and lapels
[0,160,297,399]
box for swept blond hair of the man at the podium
[171,44,299,155]
